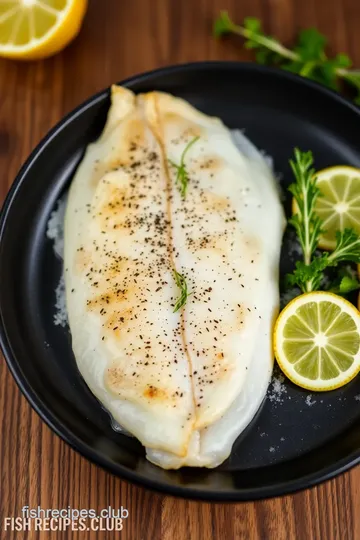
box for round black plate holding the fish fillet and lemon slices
[0,63,360,501]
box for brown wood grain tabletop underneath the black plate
[0,0,360,540]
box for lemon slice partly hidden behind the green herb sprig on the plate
[293,165,360,251]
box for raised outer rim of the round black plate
[0,61,360,502]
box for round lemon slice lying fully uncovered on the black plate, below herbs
[274,292,360,391]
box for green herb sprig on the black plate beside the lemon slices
[287,149,360,292]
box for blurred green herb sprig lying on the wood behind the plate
[214,11,360,104]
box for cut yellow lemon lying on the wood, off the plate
[0,0,87,60]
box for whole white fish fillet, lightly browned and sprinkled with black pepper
[64,87,284,468]
